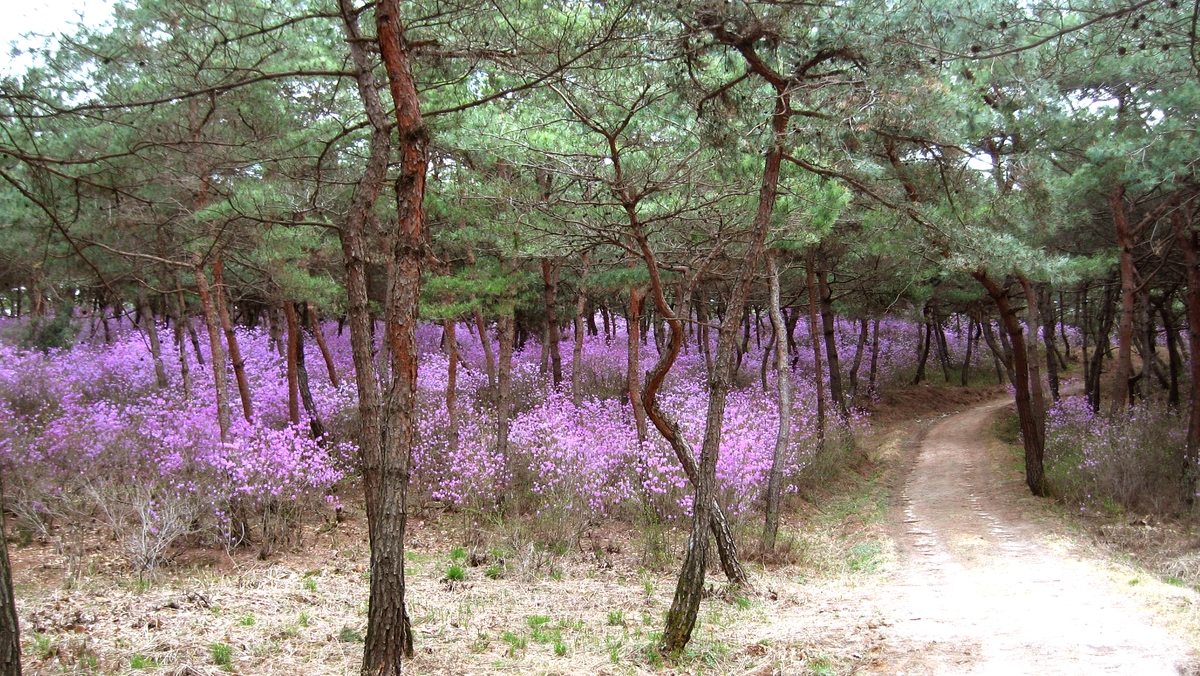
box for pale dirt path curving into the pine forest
[877,400,1198,676]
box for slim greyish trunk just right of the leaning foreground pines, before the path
[760,252,792,551]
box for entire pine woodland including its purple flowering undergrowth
[0,0,1200,674]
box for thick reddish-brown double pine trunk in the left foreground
[338,0,417,676]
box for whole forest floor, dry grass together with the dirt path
[10,388,1200,676]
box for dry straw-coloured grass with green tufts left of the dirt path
[12,474,888,675]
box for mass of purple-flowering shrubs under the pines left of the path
[0,309,960,569]
